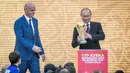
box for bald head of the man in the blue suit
[24,2,35,18]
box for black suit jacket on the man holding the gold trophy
[72,22,105,49]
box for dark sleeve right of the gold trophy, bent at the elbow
[91,23,105,41]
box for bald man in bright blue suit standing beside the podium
[14,2,45,73]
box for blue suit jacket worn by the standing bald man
[14,15,44,60]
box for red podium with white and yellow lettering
[77,50,108,73]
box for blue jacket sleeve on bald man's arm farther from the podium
[14,20,34,50]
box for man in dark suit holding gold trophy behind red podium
[72,8,105,49]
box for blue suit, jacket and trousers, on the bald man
[14,15,44,73]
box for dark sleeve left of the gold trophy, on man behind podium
[71,27,79,48]
